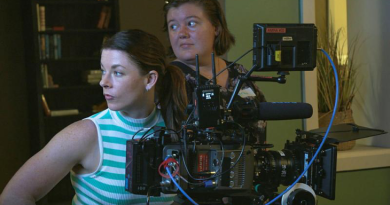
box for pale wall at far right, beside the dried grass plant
[347,0,390,147]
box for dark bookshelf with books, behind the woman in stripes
[22,0,119,203]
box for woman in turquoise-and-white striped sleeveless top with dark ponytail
[0,30,187,205]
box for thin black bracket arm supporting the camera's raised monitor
[226,65,289,109]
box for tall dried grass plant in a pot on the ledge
[317,25,358,150]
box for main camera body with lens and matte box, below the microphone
[126,123,337,204]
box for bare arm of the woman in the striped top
[0,120,97,205]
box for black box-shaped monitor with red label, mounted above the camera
[253,23,317,71]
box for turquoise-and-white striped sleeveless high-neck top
[70,109,175,205]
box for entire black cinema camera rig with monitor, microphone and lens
[125,24,384,205]
